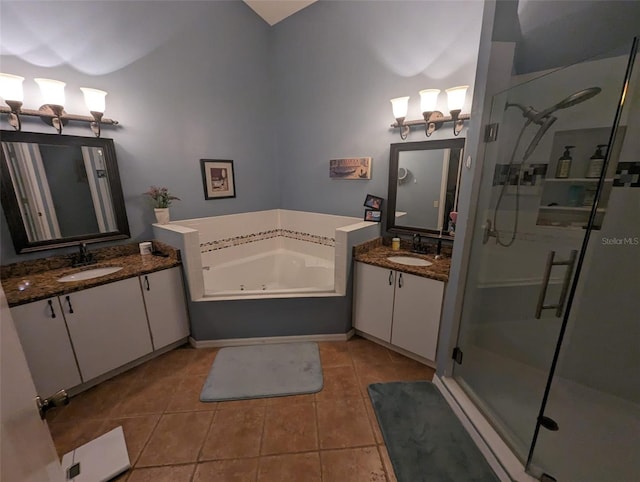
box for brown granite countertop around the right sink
[353,238,451,282]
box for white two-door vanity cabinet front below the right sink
[354,263,444,360]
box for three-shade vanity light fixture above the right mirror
[391,85,471,140]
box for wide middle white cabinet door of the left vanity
[60,277,152,381]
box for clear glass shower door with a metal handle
[453,43,627,474]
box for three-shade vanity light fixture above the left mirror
[0,73,118,137]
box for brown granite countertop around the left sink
[1,241,181,306]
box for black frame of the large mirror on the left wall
[0,130,131,254]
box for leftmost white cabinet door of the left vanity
[11,298,82,398]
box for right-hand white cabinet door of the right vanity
[391,273,444,360]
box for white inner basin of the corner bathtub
[203,249,335,300]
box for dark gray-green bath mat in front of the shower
[369,382,499,482]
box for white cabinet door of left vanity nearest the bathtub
[140,266,189,350]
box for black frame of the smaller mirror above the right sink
[387,138,466,240]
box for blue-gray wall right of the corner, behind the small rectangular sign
[273,1,482,216]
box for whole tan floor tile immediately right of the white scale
[137,412,213,467]
